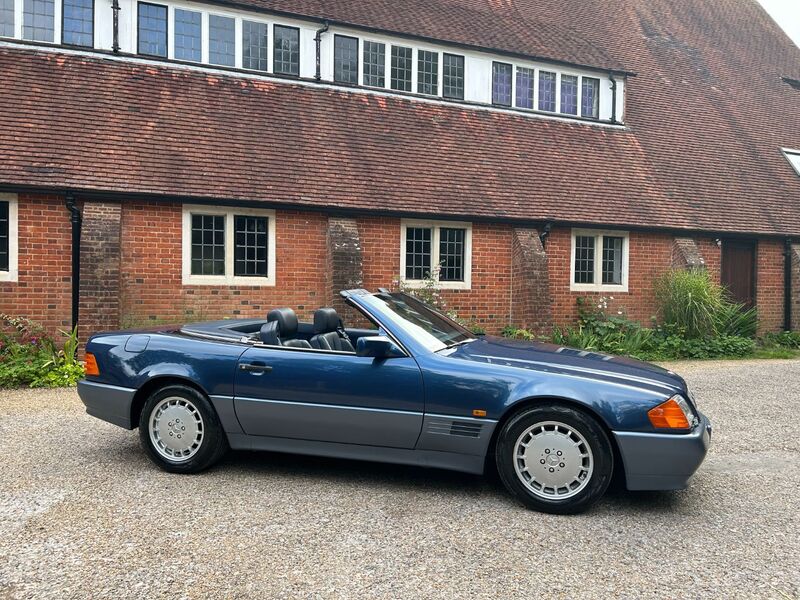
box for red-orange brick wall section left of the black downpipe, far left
[0,194,72,334]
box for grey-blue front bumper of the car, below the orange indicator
[614,413,711,490]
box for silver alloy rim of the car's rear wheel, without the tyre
[150,396,204,462]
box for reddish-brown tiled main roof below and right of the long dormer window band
[0,0,800,235]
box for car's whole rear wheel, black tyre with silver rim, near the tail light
[139,385,228,473]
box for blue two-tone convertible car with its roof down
[78,290,711,513]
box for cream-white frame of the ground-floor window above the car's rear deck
[182,204,276,287]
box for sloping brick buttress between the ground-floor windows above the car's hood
[510,228,553,333]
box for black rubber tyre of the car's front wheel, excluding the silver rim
[495,404,614,515]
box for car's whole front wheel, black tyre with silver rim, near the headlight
[495,405,614,514]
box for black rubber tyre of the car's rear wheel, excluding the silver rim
[139,385,228,473]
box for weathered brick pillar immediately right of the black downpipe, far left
[79,202,122,340]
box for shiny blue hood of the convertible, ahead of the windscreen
[449,336,686,393]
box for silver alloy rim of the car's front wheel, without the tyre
[514,421,594,500]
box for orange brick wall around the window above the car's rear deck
[120,202,328,326]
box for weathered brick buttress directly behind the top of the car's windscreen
[327,217,364,324]
